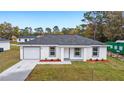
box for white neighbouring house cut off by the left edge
[0,38,10,52]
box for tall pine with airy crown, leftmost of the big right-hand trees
[82,11,106,40]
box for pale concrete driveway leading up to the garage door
[0,60,38,81]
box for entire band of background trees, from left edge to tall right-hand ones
[0,11,124,42]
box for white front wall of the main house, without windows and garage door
[20,46,107,61]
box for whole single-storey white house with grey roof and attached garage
[20,35,107,61]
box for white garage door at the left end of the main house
[24,47,40,59]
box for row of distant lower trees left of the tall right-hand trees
[0,22,80,40]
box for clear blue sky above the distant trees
[0,11,84,29]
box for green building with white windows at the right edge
[106,40,124,55]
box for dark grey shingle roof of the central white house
[21,35,104,45]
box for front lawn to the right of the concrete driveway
[26,57,124,81]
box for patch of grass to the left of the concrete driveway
[0,46,19,73]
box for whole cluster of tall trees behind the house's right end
[82,11,124,42]
